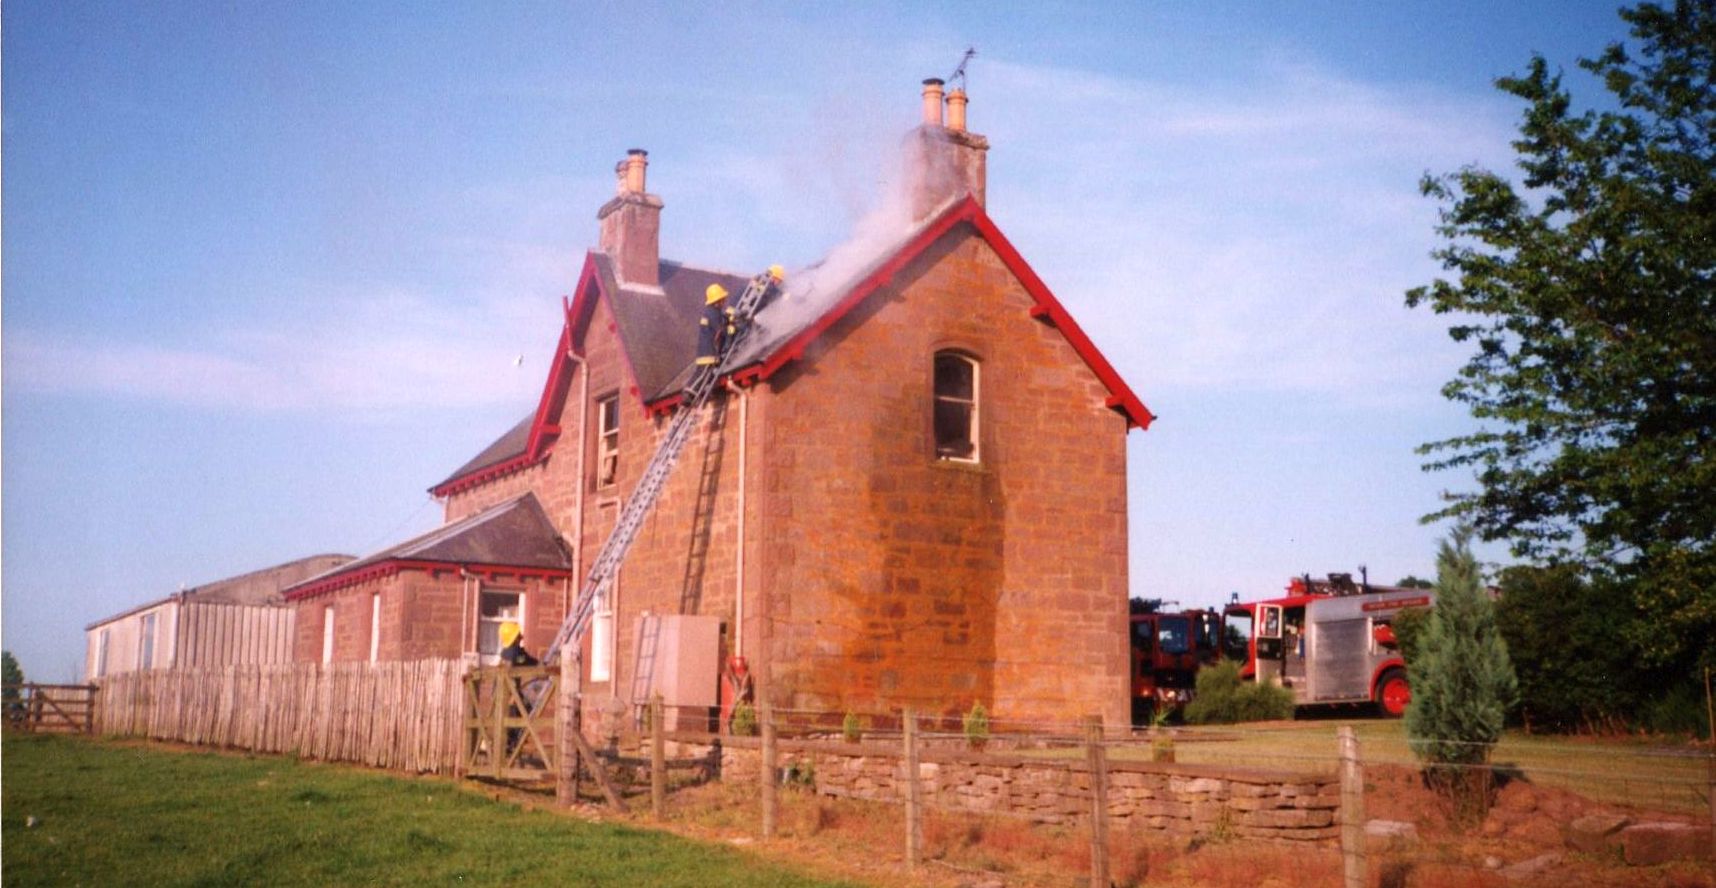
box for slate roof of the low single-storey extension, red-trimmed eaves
[287,493,571,599]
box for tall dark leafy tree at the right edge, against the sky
[1405,0,1716,670]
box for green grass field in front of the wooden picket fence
[0,733,858,888]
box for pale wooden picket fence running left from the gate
[94,660,465,773]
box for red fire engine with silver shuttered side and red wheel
[1222,574,1436,718]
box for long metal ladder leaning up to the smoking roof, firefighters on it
[542,271,777,663]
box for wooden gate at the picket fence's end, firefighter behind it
[463,666,559,782]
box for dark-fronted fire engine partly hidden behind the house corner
[1131,608,1222,725]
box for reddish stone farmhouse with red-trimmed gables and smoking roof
[287,81,1151,723]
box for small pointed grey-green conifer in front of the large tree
[1405,531,1517,821]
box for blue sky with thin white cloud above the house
[0,2,1623,680]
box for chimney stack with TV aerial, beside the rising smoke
[906,77,988,220]
